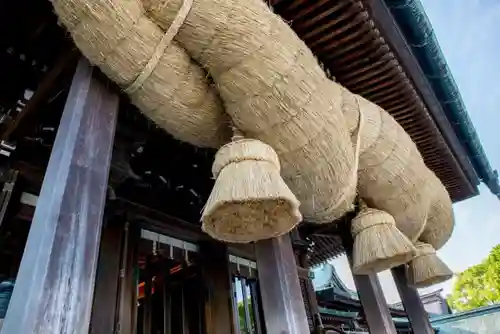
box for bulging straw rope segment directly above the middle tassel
[343,93,431,242]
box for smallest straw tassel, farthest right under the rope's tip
[406,241,453,288]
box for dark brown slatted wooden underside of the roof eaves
[270,0,478,201]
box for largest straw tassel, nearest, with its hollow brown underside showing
[202,128,302,243]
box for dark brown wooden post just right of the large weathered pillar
[90,219,125,334]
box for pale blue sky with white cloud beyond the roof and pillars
[332,0,500,303]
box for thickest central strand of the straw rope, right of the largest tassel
[143,0,356,223]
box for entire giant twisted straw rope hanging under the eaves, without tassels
[52,0,453,253]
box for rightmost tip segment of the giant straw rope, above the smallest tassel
[419,171,455,250]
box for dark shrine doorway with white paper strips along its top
[137,234,205,334]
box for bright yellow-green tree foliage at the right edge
[449,244,500,311]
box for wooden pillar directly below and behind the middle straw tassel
[340,223,396,334]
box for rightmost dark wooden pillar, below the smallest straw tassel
[391,265,434,334]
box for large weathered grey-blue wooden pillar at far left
[2,59,118,334]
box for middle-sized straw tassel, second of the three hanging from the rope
[351,205,416,275]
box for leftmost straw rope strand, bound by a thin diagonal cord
[52,0,231,147]
